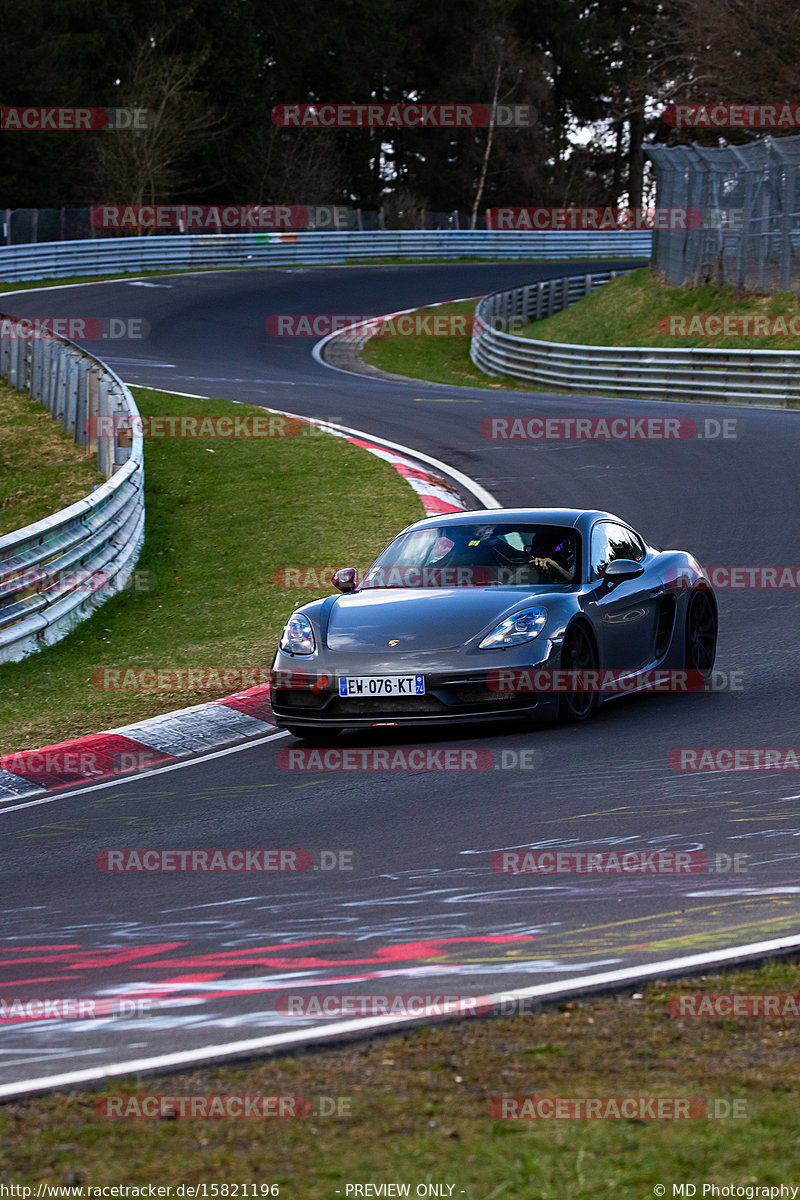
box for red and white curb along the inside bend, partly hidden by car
[0,417,474,804]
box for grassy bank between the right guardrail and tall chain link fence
[521,268,800,350]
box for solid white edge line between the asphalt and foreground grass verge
[0,936,800,1098]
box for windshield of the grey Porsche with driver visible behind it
[359,522,581,588]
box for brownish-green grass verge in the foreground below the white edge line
[0,962,800,1200]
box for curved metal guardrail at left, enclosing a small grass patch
[0,317,144,662]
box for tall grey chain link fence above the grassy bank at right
[646,137,800,294]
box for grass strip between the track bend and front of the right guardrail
[361,300,530,391]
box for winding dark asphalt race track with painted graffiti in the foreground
[0,263,800,1094]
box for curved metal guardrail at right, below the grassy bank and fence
[470,271,800,408]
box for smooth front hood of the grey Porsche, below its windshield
[326,587,547,654]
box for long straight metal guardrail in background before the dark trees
[0,229,651,283]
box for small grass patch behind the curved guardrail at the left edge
[0,383,104,536]
